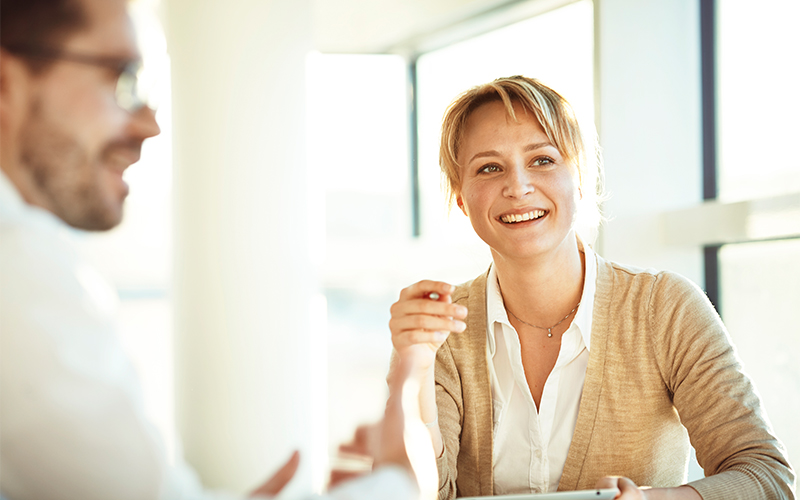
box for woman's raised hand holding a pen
[389,280,467,371]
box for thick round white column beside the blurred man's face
[165,0,326,491]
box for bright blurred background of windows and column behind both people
[72,0,800,493]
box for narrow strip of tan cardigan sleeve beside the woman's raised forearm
[435,342,464,500]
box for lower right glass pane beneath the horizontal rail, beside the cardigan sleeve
[719,239,800,464]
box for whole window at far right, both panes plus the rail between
[704,0,800,462]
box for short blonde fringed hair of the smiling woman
[439,76,603,241]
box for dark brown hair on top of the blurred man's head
[0,0,89,71]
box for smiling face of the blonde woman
[456,101,580,259]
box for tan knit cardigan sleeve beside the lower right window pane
[648,273,795,500]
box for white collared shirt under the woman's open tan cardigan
[486,245,597,495]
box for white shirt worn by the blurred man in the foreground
[0,171,418,500]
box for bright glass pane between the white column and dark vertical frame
[308,54,411,243]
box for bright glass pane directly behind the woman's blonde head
[417,0,594,243]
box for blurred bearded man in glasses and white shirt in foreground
[0,0,433,500]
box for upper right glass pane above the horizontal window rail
[717,0,800,201]
